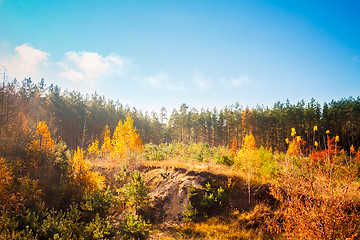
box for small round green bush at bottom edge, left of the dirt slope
[121,212,151,239]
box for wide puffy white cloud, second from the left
[59,51,126,85]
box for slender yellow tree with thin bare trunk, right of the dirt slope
[235,133,260,204]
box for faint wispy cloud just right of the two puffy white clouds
[141,72,184,91]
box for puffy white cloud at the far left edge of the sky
[0,44,50,80]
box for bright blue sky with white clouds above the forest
[0,0,360,111]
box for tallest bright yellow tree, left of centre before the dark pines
[111,116,142,159]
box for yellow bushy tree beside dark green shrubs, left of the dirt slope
[69,147,105,198]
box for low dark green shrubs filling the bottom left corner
[0,202,114,239]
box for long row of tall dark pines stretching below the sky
[0,78,360,155]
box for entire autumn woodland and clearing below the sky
[0,78,360,239]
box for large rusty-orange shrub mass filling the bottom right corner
[269,129,360,239]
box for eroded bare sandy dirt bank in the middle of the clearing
[96,160,273,227]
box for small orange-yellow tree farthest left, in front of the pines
[28,121,54,153]
